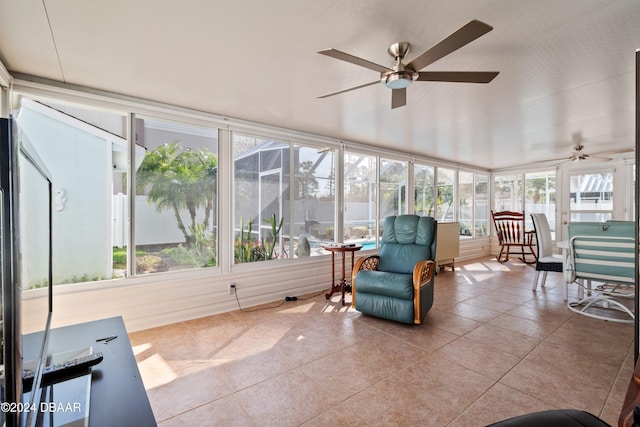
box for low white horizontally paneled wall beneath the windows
[22,256,339,333]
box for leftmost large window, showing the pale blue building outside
[15,97,128,284]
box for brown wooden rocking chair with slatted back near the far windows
[491,211,537,264]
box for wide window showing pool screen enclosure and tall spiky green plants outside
[233,133,336,264]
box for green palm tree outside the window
[136,142,218,247]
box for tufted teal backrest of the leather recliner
[378,215,437,274]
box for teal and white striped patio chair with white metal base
[568,221,636,323]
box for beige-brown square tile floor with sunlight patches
[130,258,633,427]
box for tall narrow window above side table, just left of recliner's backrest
[343,153,378,249]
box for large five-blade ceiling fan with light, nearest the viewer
[318,20,498,108]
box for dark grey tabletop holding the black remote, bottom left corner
[23,317,157,427]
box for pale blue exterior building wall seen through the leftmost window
[17,102,112,283]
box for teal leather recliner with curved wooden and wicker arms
[351,215,438,324]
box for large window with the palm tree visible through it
[134,117,218,274]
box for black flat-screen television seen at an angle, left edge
[0,118,53,427]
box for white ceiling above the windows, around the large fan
[0,0,640,169]
